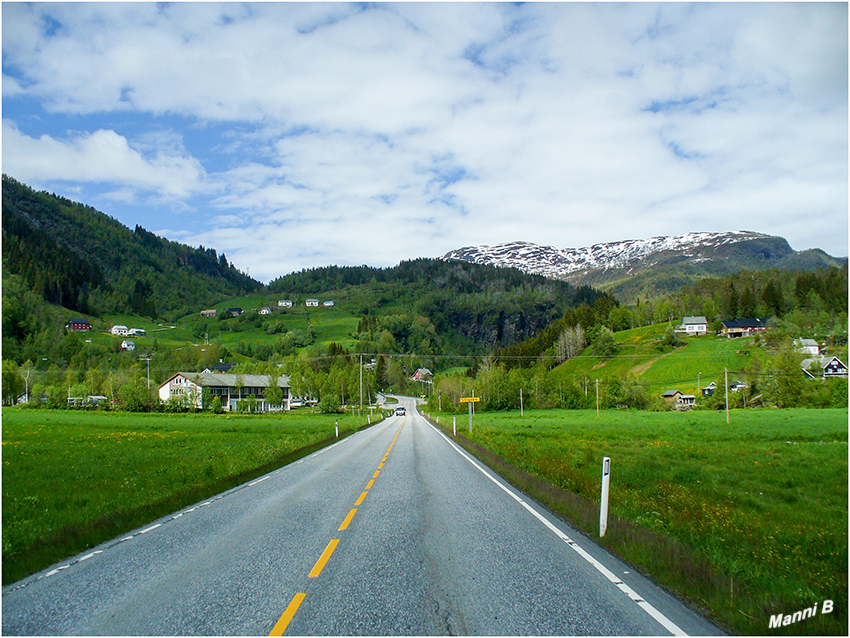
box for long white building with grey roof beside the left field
[159,372,290,412]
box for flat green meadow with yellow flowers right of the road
[434,409,848,636]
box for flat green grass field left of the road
[2,408,378,585]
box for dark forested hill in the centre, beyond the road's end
[269,259,617,355]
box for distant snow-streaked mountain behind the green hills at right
[441,231,846,300]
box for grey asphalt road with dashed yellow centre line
[2,400,721,636]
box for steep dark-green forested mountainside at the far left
[3,175,262,320]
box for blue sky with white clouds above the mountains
[2,2,848,282]
